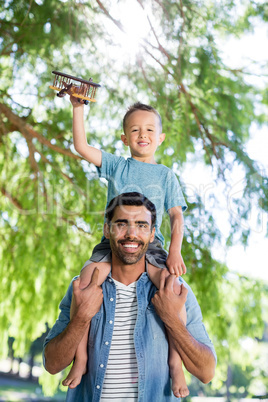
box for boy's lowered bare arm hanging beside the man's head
[166,206,186,276]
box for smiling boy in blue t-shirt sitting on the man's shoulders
[63,96,189,397]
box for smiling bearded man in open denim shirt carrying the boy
[44,193,216,402]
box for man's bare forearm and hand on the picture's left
[44,268,103,374]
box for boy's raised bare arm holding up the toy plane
[70,96,102,167]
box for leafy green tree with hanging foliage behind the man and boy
[0,0,267,396]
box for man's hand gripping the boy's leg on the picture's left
[73,267,103,323]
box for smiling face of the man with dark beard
[104,205,155,265]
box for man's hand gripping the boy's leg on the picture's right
[152,270,188,324]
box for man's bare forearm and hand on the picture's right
[152,270,216,384]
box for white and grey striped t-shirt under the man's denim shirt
[101,279,138,402]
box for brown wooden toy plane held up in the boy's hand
[49,71,100,105]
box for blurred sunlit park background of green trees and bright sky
[0,0,268,402]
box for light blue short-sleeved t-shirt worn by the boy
[97,151,187,246]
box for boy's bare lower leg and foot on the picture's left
[62,297,89,388]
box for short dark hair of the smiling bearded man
[105,191,156,227]
